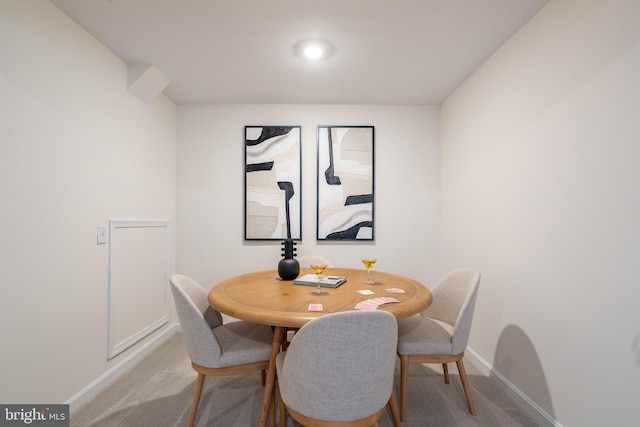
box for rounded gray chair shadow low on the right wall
[493,325,555,419]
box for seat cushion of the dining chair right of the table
[398,316,454,355]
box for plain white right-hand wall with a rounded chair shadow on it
[441,0,640,426]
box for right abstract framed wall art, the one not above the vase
[316,126,374,240]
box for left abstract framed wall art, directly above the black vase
[244,126,302,240]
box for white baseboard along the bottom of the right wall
[465,347,562,427]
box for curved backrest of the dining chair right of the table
[421,268,480,354]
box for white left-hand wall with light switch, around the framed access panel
[0,0,176,403]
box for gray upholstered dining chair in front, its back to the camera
[276,310,400,427]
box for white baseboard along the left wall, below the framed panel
[64,323,181,413]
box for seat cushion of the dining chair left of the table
[213,320,273,368]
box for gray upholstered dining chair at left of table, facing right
[170,275,273,427]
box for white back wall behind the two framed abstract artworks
[176,105,440,287]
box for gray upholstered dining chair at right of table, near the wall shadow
[398,268,480,421]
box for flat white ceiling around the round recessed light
[51,0,548,105]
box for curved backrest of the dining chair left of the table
[170,274,222,368]
